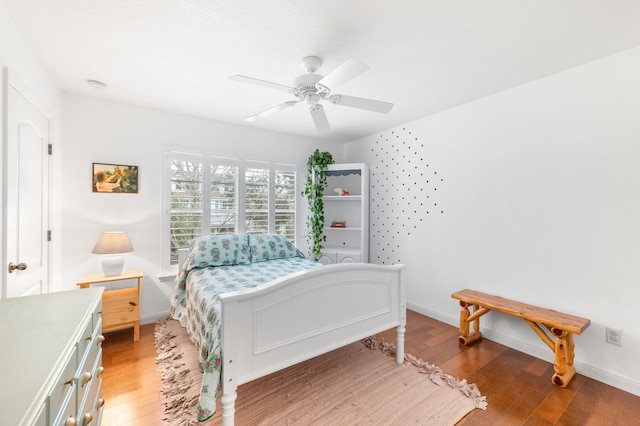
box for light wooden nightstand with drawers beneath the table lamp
[77,269,144,342]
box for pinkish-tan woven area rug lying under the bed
[155,319,487,426]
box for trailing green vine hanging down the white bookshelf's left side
[302,149,333,261]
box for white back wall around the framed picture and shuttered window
[56,95,343,323]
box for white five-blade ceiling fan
[229,56,393,132]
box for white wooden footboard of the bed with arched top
[220,263,406,426]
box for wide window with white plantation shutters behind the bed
[165,152,296,269]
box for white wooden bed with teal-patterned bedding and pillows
[170,234,406,426]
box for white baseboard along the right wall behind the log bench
[407,302,640,396]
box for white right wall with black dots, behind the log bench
[345,47,640,395]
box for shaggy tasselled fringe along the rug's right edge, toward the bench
[362,337,489,410]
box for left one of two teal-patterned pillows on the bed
[186,234,251,270]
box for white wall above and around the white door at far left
[0,5,62,285]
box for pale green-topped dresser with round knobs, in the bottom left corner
[0,287,104,426]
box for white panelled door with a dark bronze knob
[2,70,51,297]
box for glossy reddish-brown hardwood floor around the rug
[102,311,640,426]
